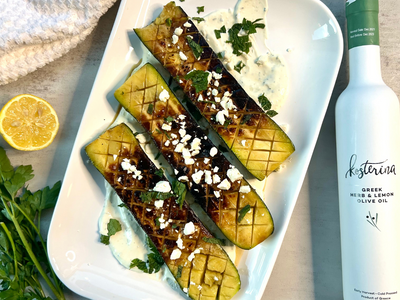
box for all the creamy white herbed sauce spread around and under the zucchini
[99,0,282,282]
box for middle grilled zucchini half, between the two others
[114,64,274,249]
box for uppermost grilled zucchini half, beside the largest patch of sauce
[135,2,295,180]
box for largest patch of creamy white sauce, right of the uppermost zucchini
[196,0,288,111]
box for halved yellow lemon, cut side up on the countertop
[0,94,60,151]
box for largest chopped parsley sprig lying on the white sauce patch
[226,18,265,56]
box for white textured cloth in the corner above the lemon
[0,0,116,85]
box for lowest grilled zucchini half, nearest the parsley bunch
[86,124,240,300]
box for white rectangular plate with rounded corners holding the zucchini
[48,0,343,300]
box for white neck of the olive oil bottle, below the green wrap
[349,45,383,85]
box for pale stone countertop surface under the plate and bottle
[0,0,400,300]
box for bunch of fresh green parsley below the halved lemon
[0,147,65,300]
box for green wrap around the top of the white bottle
[346,0,379,49]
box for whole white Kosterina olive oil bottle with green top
[335,0,400,300]
